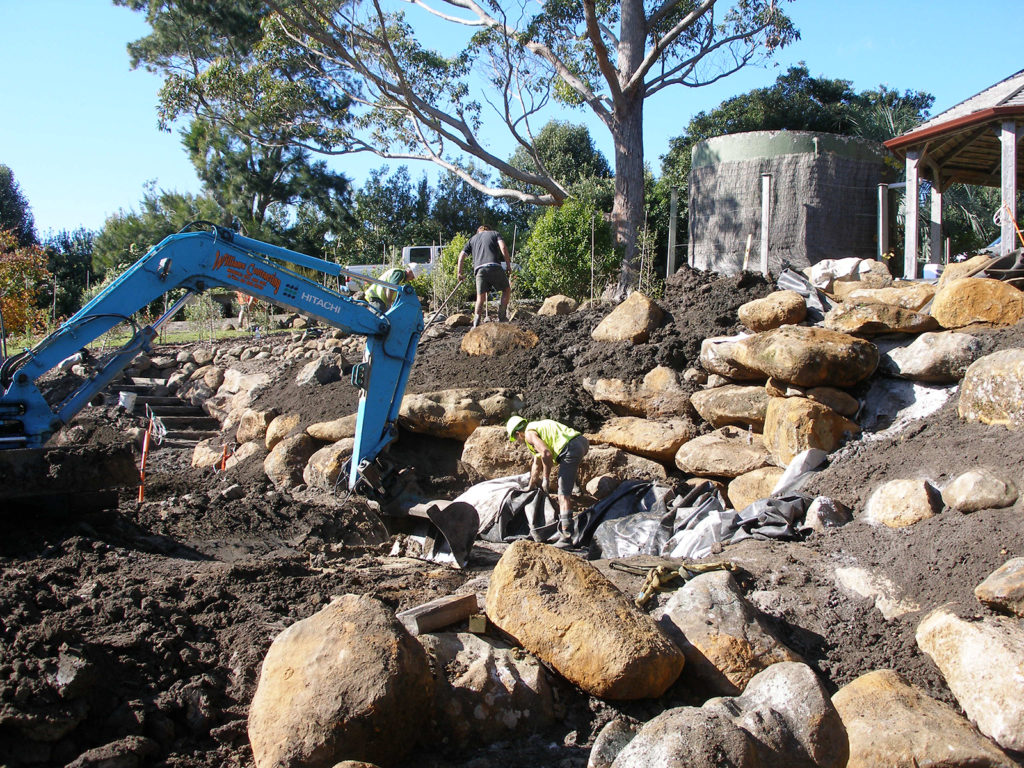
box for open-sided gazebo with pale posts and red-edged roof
[885,70,1024,279]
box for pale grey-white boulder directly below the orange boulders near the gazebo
[879,331,982,384]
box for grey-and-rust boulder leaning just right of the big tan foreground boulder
[657,570,803,696]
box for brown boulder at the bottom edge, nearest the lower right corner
[833,670,1016,768]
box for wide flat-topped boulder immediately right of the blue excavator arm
[398,387,522,440]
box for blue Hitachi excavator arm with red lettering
[0,226,423,487]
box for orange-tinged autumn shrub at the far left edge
[0,229,52,334]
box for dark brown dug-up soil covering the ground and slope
[0,268,1024,768]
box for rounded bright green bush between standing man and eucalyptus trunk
[523,200,616,299]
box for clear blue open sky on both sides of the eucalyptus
[0,0,1024,237]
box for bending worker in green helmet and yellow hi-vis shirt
[505,416,590,540]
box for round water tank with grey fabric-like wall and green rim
[689,131,891,274]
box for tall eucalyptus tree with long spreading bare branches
[116,0,798,289]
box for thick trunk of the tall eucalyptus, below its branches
[611,92,644,300]
